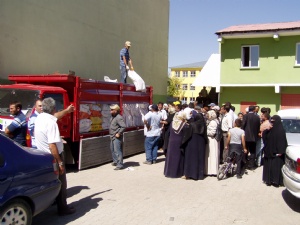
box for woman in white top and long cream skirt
[205,110,220,175]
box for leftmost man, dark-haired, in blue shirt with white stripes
[5,102,27,146]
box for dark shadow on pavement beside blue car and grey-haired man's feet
[32,189,112,225]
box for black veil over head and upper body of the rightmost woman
[263,115,288,157]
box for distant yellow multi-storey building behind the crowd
[170,61,209,103]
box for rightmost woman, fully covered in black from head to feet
[262,115,287,187]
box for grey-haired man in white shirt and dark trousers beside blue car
[35,98,76,216]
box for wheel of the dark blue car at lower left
[0,199,32,225]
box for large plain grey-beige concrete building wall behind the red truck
[0,0,169,101]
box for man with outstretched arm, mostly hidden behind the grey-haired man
[28,99,74,148]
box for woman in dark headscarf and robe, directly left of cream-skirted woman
[182,113,207,180]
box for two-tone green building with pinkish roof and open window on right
[216,21,300,114]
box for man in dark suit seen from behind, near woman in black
[242,105,260,170]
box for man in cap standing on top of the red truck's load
[120,41,133,84]
